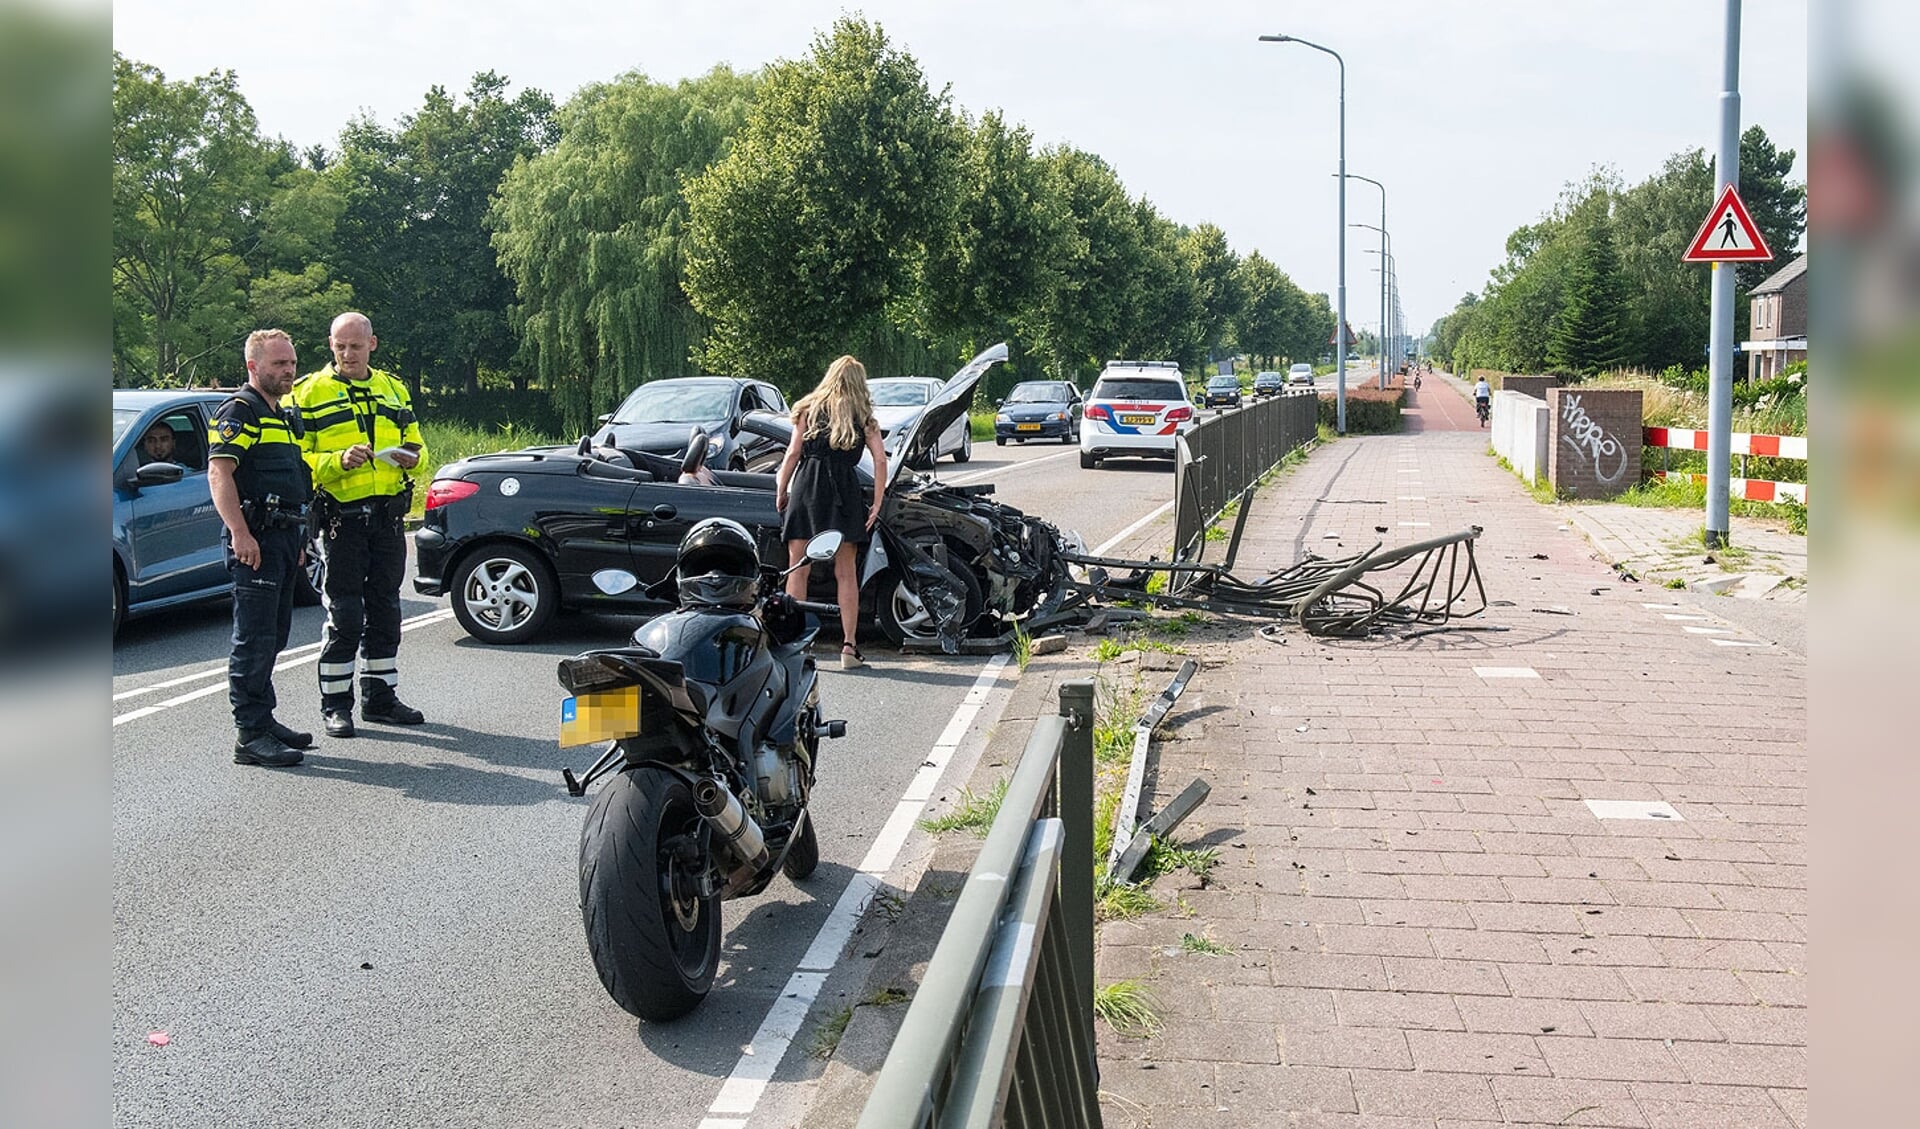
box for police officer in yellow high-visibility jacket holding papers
[294,313,426,737]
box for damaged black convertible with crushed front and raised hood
[413,346,1079,653]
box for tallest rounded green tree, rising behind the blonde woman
[685,17,966,390]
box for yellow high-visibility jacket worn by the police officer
[292,365,426,501]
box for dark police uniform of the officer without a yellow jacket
[207,386,313,743]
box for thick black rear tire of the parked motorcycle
[580,768,720,1021]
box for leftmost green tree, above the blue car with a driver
[113,52,269,384]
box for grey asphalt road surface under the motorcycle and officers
[113,435,1173,1129]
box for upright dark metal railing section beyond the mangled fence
[1173,392,1319,561]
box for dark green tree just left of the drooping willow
[326,71,555,392]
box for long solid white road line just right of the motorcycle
[699,652,1013,1129]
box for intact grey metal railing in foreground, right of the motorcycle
[858,680,1100,1129]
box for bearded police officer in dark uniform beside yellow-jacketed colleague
[207,330,313,768]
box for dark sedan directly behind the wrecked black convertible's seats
[593,376,787,470]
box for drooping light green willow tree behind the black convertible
[492,67,755,432]
